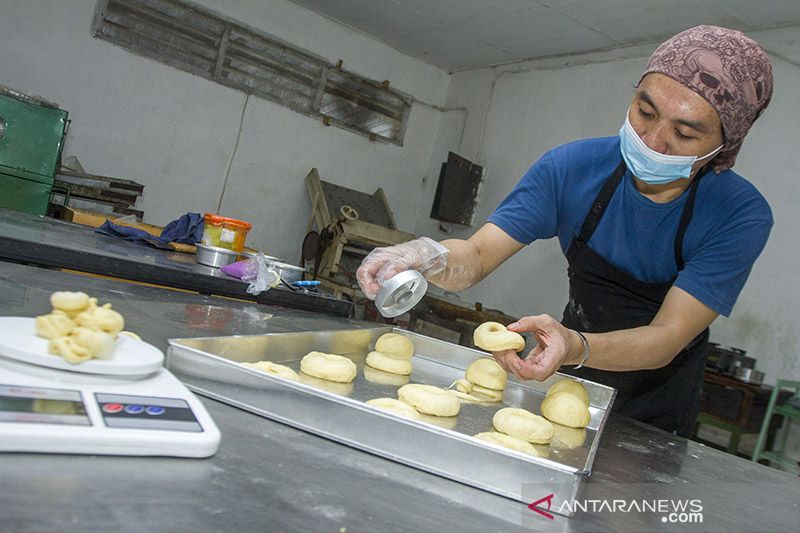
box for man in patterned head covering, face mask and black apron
[358,26,772,436]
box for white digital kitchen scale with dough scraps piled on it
[0,317,220,457]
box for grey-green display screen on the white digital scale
[0,384,92,426]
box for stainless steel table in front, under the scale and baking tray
[0,262,800,533]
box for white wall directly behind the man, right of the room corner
[416,27,800,382]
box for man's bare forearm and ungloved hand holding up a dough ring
[494,286,717,381]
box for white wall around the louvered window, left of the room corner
[0,0,449,262]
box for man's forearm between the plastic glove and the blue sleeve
[428,223,524,291]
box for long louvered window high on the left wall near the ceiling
[92,0,412,144]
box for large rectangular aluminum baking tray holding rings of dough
[167,326,616,514]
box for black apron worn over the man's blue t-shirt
[560,162,708,437]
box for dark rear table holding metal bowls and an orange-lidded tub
[0,208,353,317]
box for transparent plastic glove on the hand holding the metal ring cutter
[356,237,449,300]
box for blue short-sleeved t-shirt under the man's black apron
[489,137,772,316]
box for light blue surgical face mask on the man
[619,113,724,185]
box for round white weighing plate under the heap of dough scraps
[0,316,164,376]
